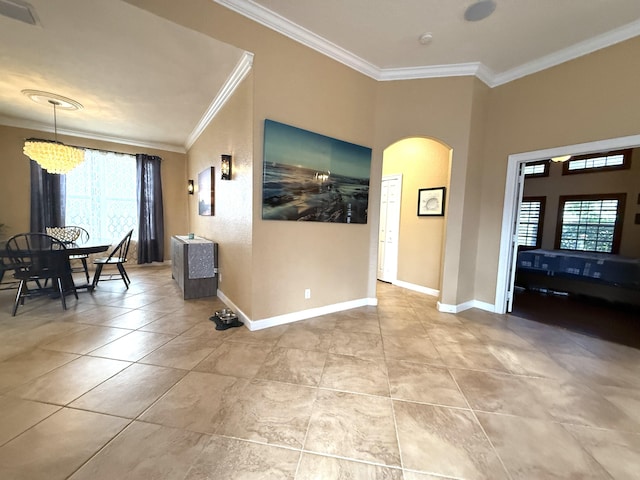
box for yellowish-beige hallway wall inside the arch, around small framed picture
[382,138,451,290]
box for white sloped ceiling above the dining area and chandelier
[0,0,243,151]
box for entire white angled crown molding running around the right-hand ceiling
[214,0,640,88]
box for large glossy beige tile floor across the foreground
[0,267,640,480]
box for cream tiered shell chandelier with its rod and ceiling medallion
[22,90,84,174]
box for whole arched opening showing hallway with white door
[377,137,451,296]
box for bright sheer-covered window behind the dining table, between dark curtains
[65,149,138,242]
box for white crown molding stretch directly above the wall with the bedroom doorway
[488,16,640,87]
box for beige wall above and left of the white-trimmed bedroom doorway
[474,38,640,303]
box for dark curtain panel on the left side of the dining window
[30,160,66,233]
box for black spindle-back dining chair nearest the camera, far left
[6,233,78,317]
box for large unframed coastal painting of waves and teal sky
[262,119,371,223]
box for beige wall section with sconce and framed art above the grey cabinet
[187,74,253,317]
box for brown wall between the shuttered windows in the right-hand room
[524,148,640,257]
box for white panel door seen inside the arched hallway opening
[378,175,402,282]
